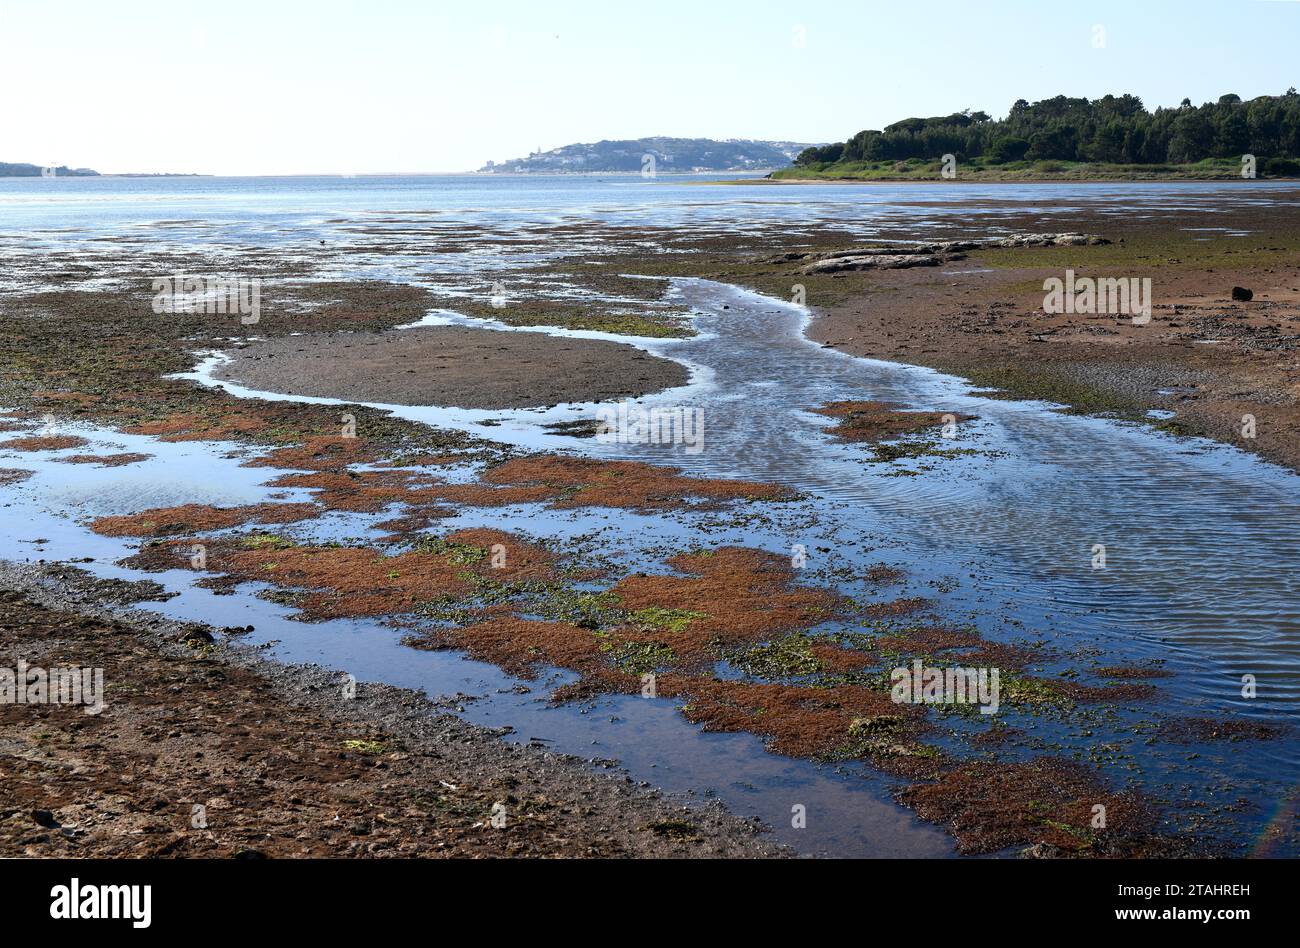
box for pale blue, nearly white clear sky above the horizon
[0,0,1300,174]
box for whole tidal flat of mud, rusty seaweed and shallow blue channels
[0,171,1300,857]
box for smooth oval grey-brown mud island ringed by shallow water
[216,326,689,408]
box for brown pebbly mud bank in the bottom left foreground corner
[0,562,780,858]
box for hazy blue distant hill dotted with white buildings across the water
[480,138,810,174]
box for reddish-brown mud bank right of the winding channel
[809,237,1300,469]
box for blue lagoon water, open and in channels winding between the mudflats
[0,176,1300,856]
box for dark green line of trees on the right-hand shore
[794,87,1300,174]
